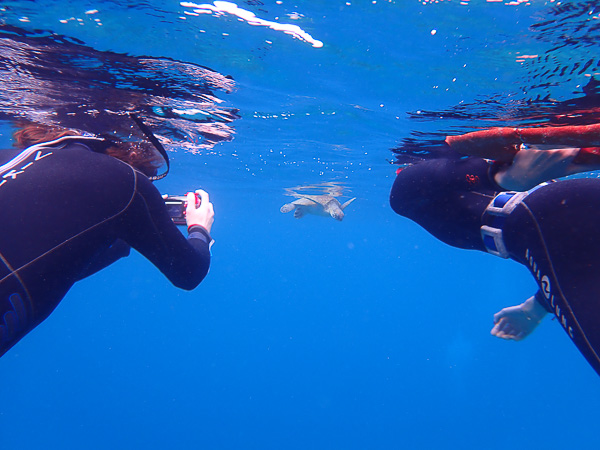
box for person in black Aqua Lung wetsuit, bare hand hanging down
[390,148,600,375]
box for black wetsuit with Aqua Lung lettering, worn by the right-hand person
[390,158,600,374]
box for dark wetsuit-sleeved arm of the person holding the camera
[122,174,212,290]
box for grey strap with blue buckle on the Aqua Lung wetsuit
[481,192,528,259]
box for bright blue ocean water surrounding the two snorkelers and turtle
[0,0,600,449]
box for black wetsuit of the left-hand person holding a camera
[0,139,210,355]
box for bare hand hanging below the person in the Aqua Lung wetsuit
[491,296,548,341]
